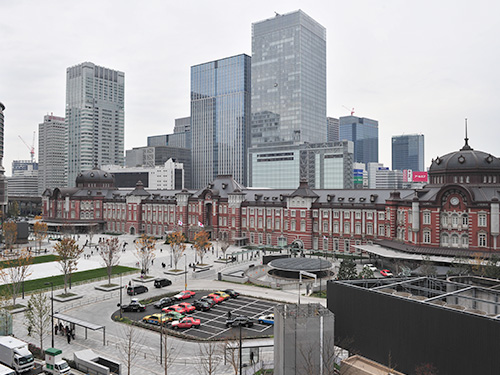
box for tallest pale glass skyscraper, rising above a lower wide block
[251,10,326,147]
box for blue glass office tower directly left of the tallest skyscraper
[191,54,251,189]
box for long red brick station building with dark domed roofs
[42,138,500,256]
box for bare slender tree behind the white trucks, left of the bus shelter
[24,292,52,352]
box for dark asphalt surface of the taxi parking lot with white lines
[114,290,276,340]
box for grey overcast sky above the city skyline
[0,0,500,175]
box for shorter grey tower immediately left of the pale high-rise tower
[38,115,68,194]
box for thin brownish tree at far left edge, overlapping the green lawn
[0,249,33,306]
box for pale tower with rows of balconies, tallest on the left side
[66,62,125,186]
